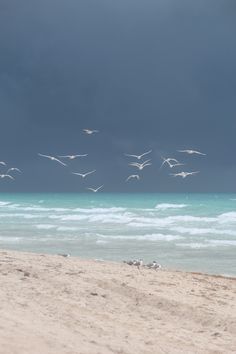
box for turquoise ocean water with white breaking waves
[0,193,236,276]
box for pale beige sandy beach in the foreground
[0,251,236,354]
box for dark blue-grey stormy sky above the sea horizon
[0,0,236,192]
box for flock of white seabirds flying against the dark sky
[0,129,206,193]
